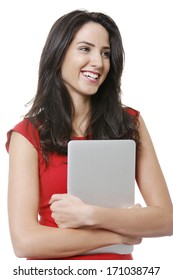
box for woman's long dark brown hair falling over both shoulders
[25,10,139,160]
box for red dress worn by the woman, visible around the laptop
[6,109,139,260]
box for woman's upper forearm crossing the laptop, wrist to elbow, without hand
[88,206,173,237]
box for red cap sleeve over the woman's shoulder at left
[6,118,40,151]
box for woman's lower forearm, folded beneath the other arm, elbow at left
[12,225,134,259]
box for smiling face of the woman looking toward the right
[61,22,110,98]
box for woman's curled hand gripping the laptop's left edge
[49,194,89,228]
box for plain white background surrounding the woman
[0,0,173,279]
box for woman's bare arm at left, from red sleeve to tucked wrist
[8,132,141,258]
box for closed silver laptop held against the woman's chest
[67,140,136,254]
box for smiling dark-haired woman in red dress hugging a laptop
[7,10,173,259]
